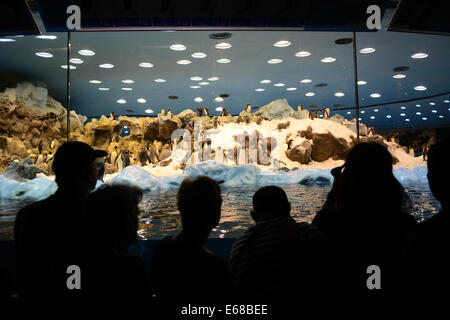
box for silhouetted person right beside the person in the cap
[86,184,151,304]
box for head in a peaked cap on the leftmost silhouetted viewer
[52,141,107,195]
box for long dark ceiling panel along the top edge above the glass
[37,0,388,32]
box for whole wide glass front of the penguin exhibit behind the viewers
[0,10,450,239]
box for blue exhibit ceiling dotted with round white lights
[0,31,450,128]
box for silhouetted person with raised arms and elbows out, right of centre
[313,143,415,297]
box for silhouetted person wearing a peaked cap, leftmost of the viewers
[14,142,107,302]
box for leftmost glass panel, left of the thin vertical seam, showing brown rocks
[0,33,67,240]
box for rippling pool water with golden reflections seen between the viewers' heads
[0,185,440,240]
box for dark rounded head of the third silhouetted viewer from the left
[177,176,222,237]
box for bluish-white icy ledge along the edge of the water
[0,160,428,201]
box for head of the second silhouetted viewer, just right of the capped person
[87,184,142,252]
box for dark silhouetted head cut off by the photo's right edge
[427,139,450,207]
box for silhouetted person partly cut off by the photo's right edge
[414,140,450,299]
